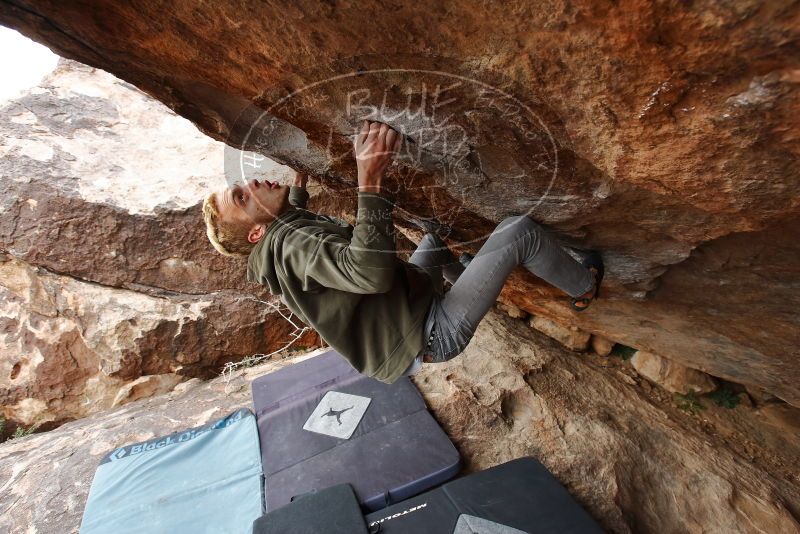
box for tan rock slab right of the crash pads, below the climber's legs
[415,313,800,532]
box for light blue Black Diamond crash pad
[80,409,263,534]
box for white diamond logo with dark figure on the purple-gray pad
[303,391,372,439]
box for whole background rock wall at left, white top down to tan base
[0,61,319,432]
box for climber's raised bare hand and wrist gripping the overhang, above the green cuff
[355,121,402,193]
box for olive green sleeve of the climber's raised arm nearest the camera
[290,193,397,294]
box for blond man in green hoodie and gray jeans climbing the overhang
[203,122,603,383]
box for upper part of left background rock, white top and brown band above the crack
[0,60,286,294]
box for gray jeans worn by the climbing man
[405,215,594,375]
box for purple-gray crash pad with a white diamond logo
[252,350,460,511]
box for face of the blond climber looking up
[216,180,289,243]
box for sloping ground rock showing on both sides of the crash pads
[0,312,800,534]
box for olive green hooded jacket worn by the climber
[247,187,436,383]
